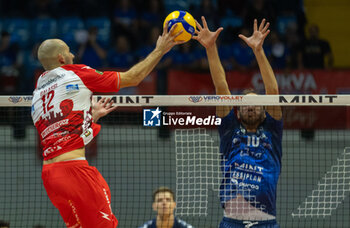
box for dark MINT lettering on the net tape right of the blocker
[279,95,338,103]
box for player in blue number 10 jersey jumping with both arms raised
[193,17,283,228]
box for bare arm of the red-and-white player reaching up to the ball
[120,23,183,88]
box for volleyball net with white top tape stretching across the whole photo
[0,95,350,228]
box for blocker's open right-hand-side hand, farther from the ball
[238,19,270,51]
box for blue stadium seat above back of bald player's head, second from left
[32,18,57,42]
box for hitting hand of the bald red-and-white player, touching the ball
[156,21,184,54]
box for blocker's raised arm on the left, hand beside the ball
[193,16,232,117]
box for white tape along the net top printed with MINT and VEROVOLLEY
[0,94,350,107]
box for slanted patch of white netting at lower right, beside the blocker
[292,147,350,217]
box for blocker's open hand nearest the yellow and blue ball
[192,16,223,48]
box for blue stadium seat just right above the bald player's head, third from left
[58,17,85,49]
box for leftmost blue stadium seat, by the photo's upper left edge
[3,18,31,47]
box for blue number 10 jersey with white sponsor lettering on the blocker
[219,109,283,216]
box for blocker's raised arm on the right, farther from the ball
[238,19,282,120]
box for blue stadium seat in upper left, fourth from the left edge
[85,17,111,47]
